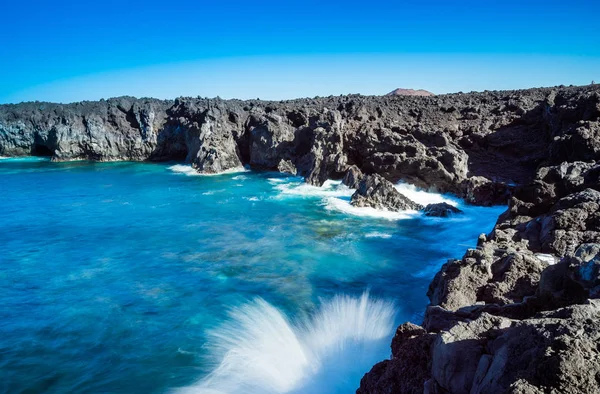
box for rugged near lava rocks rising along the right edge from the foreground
[358,85,600,394]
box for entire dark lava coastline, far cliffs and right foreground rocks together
[0,85,600,394]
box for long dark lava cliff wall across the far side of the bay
[0,86,600,205]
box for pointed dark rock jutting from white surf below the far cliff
[350,174,423,211]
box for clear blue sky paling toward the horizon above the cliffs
[0,0,600,103]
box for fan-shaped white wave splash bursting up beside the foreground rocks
[181,293,395,394]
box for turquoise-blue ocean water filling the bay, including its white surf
[0,159,503,393]
